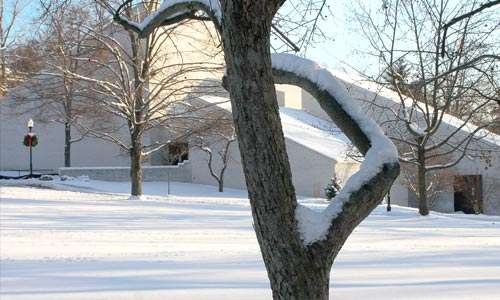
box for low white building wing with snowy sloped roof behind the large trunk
[189,95,359,197]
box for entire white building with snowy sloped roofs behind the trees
[0,21,500,214]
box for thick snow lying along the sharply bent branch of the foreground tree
[272,54,398,245]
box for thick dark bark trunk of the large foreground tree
[222,0,333,300]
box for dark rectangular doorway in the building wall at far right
[453,175,483,214]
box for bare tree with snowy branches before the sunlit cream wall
[61,4,220,196]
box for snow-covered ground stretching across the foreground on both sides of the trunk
[0,180,500,300]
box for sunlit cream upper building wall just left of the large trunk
[149,21,224,109]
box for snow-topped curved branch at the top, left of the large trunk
[114,0,222,37]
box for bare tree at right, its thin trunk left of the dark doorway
[359,0,500,215]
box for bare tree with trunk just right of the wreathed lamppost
[12,2,106,167]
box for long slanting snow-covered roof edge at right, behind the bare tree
[329,69,500,146]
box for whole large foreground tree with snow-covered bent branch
[103,0,399,299]
